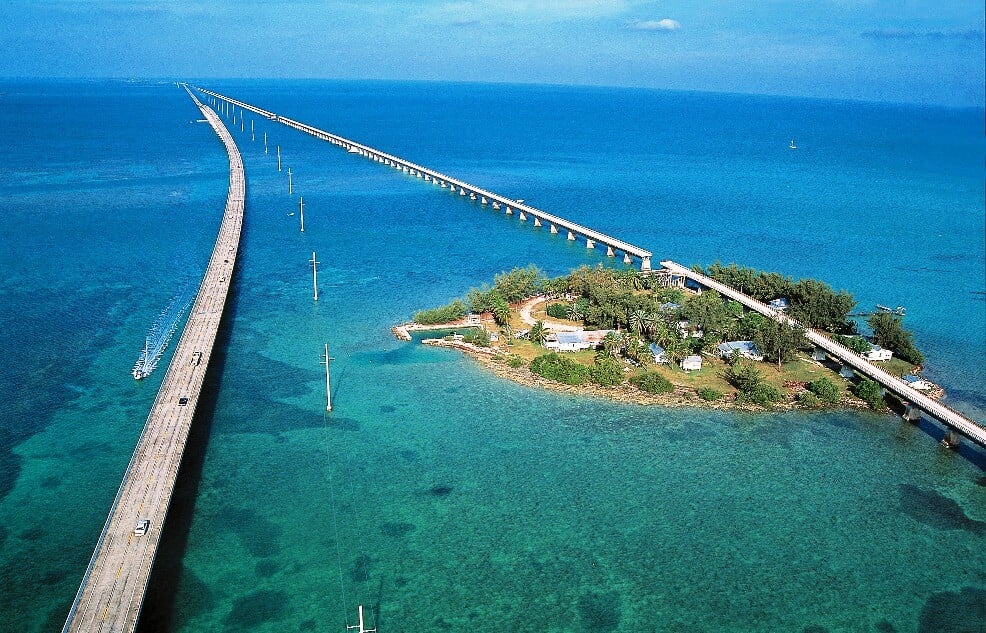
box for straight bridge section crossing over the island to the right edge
[661,260,986,447]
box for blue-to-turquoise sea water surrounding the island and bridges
[0,81,986,632]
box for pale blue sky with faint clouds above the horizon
[0,0,986,106]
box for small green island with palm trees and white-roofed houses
[393,263,943,411]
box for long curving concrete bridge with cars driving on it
[62,87,246,633]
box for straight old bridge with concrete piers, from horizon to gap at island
[196,88,652,271]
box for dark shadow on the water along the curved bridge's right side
[136,262,246,633]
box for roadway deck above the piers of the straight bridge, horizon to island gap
[196,88,652,266]
